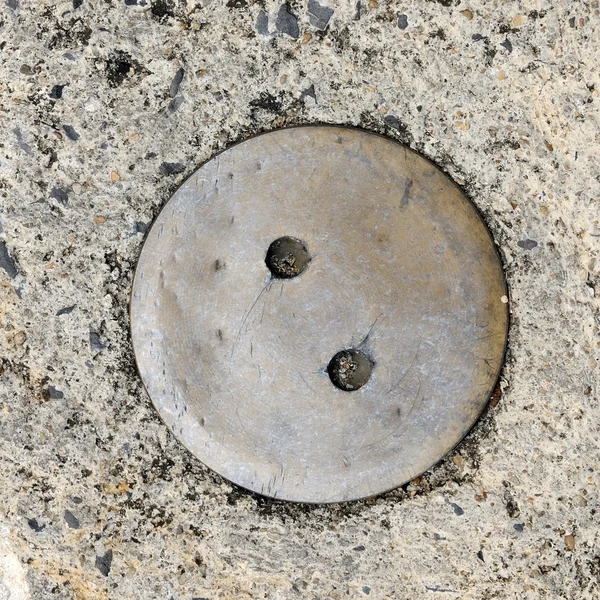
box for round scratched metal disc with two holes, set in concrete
[131,127,508,502]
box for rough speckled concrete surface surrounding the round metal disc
[0,0,600,600]
